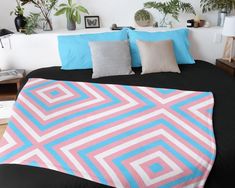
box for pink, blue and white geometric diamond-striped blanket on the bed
[0,79,216,188]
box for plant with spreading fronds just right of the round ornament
[144,0,195,27]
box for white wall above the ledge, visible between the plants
[0,0,217,29]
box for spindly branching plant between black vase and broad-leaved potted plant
[20,0,58,31]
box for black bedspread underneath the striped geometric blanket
[0,61,235,188]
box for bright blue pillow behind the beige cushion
[128,29,195,67]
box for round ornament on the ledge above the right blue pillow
[135,9,151,27]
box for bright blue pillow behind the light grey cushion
[58,30,128,70]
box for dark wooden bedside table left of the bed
[0,69,26,101]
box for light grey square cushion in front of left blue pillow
[89,41,134,78]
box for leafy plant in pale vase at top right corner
[200,0,235,26]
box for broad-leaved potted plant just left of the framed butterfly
[55,0,89,30]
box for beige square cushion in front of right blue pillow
[137,40,180,74]
